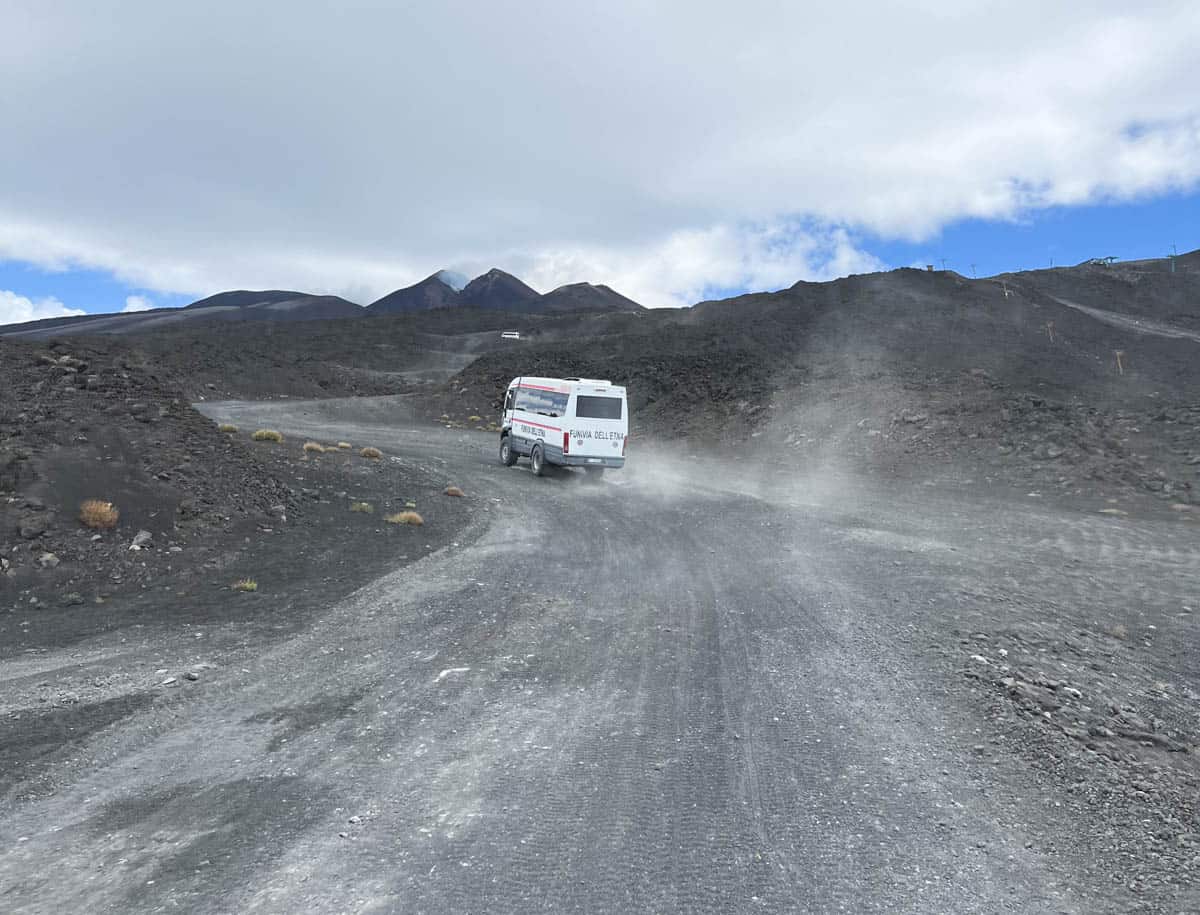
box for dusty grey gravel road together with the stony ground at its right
[0,401,1200,913]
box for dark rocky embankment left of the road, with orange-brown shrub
[0,341,295,605]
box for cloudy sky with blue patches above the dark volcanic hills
[0,0,1200,323]
